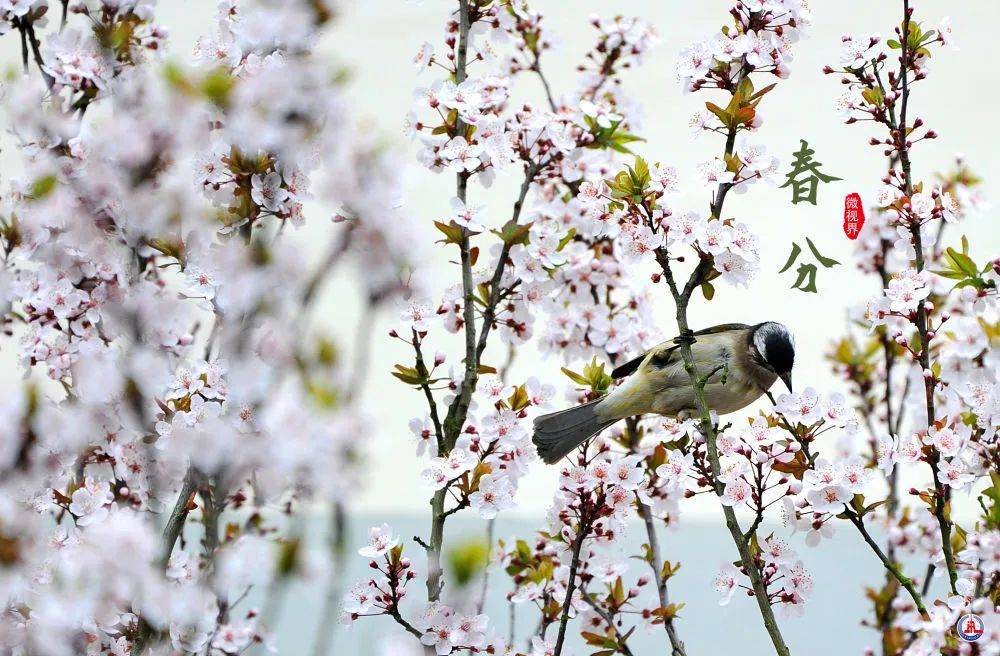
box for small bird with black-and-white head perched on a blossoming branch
[532,321,795,465]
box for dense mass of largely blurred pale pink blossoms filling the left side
[0,0,418,655]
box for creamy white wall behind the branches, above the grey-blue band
[0,0,1000,517]
